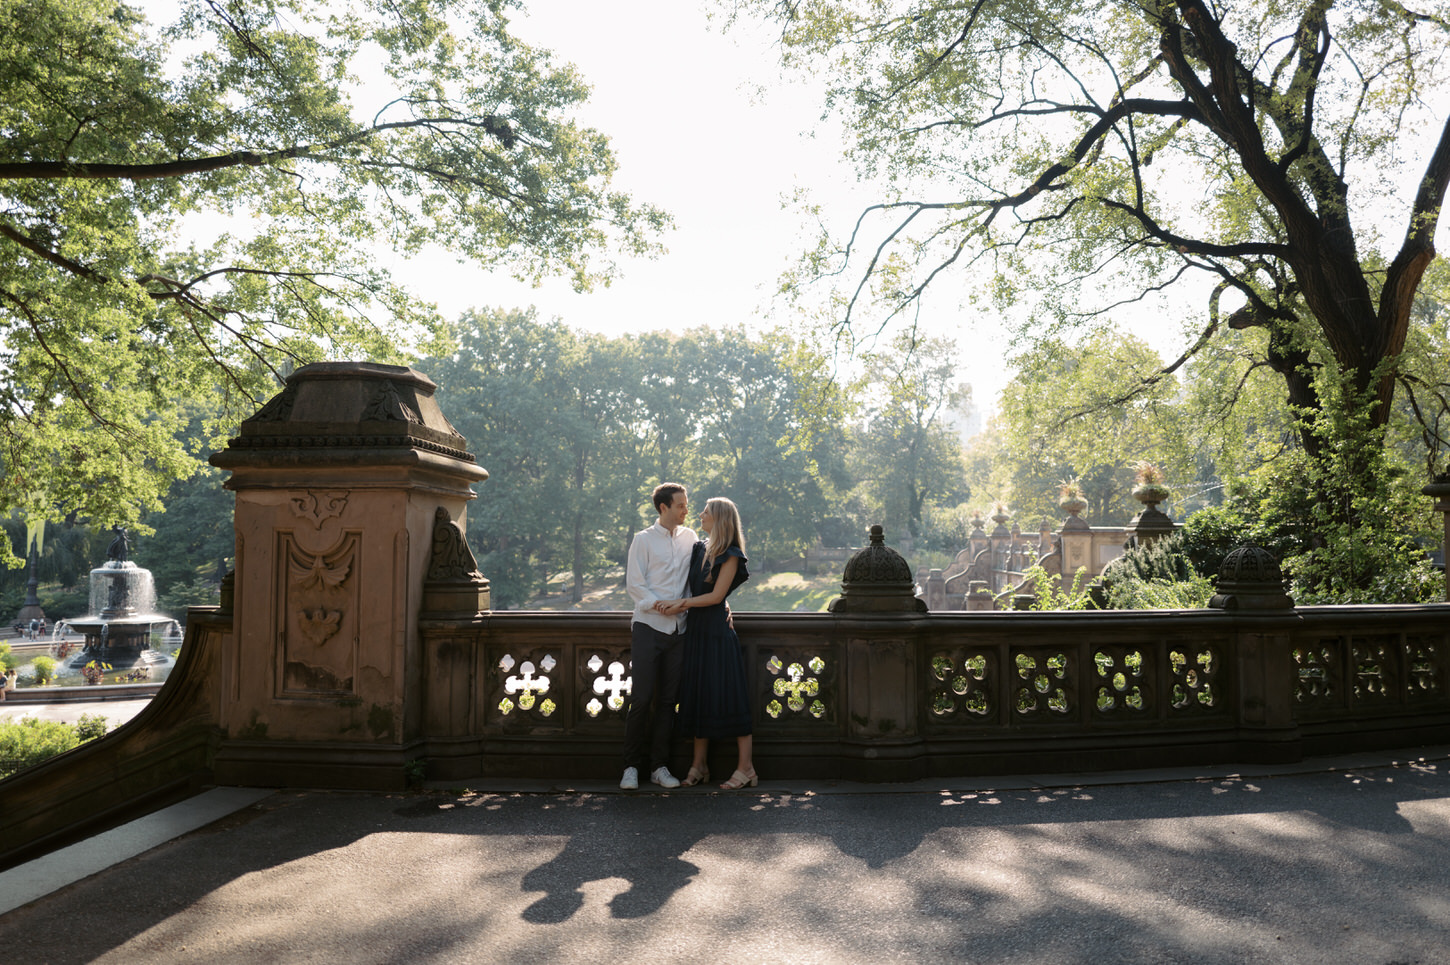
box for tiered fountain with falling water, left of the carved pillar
[65,526,175,671]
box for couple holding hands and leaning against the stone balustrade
[619,483,757,791]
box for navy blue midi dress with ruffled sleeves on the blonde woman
[674,543,751,738]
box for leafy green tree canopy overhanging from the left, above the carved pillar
[0,0,666,553]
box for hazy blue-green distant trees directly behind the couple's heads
[418,310,841,607]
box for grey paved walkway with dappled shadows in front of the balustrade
[0,748,1450,965]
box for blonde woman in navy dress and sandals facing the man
[658,496,758,791]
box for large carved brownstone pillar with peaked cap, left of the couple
[212,362,487,787]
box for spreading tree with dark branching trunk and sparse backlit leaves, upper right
[732,0,1450,451]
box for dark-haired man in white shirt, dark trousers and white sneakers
[619,483,696,791]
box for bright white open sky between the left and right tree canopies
[393,0,1005,407]
